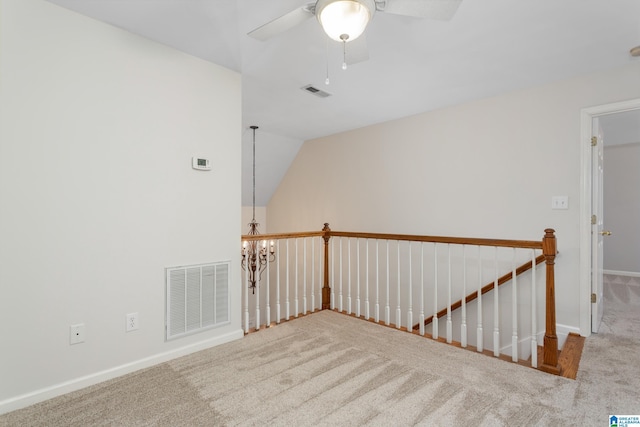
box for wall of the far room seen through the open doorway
[604,142,640,275]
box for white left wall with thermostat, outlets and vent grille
[0,0,242,412]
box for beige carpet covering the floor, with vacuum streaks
[0,283,640,426]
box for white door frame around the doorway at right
[579,98,640,337]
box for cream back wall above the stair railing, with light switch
[268,61,640,333]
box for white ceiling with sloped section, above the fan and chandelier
[49,0,640,206]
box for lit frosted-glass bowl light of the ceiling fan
[316,0,376,42]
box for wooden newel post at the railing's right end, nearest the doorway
[540,228,560,375]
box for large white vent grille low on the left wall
[166,262,229,340]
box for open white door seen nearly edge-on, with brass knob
[591,117,605,332]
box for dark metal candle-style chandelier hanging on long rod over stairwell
[242,126,276,294]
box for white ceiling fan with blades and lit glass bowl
[248,0,462,43]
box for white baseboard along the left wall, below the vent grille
[0,329,244,414]
